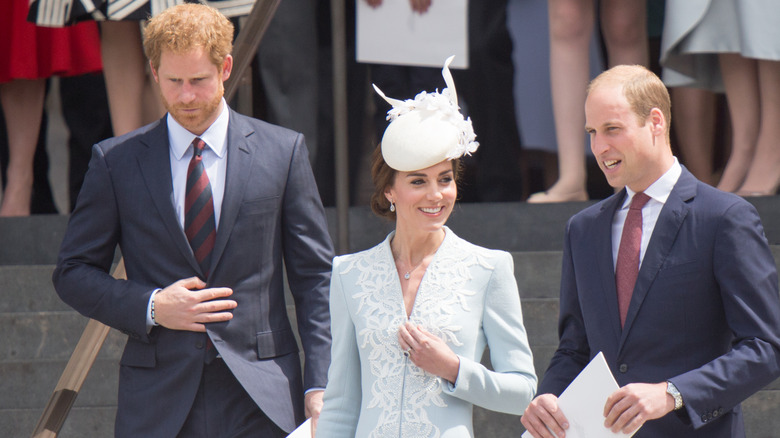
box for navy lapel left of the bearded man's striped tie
[137,117,200,272]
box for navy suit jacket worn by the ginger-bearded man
[53,110,333,437]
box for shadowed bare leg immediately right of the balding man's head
[672,87,716,184]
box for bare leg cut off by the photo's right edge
[739,60,780,196]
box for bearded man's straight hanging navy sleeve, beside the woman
[282,134,333,390]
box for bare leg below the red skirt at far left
[0,79,46,216]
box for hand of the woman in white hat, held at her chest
[398,322,460,383]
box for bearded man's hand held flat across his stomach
[154,277,238,332]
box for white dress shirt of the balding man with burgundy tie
[612,157,682,268]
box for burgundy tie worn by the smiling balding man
[615,192,650,327]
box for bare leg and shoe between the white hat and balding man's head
[528,0,595,203]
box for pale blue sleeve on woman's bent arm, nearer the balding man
[444,252,537,415]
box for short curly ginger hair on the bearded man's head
[144,3,234,71]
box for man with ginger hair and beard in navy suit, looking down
[53,4,333,438]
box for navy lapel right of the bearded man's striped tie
[210,109,255,272]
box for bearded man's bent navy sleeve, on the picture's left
[52,146,153,342]
